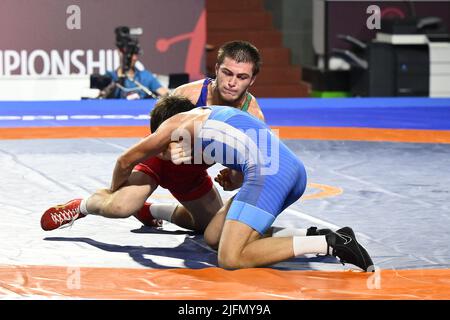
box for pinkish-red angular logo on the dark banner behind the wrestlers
[156,10,206,80]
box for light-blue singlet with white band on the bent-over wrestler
[197,106,306,234]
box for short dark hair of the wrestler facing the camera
[217,40,262,76]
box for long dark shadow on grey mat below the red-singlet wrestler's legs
[44,235,217,269]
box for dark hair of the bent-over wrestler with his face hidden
[150,96,195,132]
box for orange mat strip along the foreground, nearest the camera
[0,266,450,300]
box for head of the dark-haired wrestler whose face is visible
[216,41,261,104]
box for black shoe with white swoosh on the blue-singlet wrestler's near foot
[326,227,374,271]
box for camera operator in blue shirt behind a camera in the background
[100,27,169,100]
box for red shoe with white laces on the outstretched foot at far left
[41,199,86,231]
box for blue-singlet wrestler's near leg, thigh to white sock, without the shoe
[218,167,328,269]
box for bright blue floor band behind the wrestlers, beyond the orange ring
[0,98,450,130]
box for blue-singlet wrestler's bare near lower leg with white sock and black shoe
[218,207,373,271]
